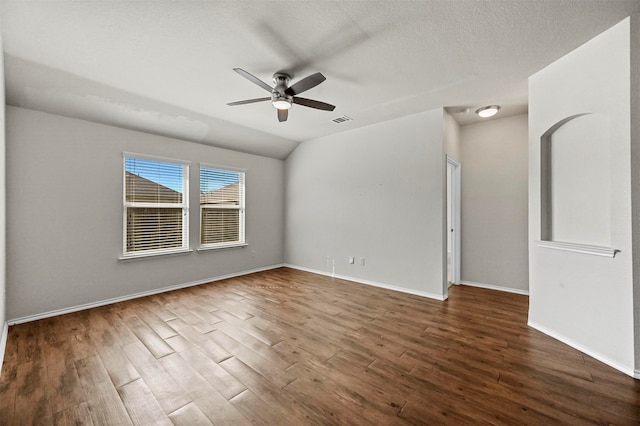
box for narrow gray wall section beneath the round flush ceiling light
[460,114,529,293]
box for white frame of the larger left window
[120,152,192,260]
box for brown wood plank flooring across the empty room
[0,268,640,425]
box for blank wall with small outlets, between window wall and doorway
[285,109,445,297]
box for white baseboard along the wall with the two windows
[7,264,284,325]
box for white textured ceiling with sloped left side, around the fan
[0,0,640,158]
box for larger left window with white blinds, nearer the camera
[123,154,189,257]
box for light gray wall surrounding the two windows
[7,107,284,319]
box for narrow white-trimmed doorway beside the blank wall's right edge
[444,155,460,296]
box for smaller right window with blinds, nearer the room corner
[200,165,245,248]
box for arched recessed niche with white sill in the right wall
[540,113,615,256]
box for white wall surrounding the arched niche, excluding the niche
[529,19,634,374]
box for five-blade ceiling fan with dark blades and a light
[227,68,336,122]
